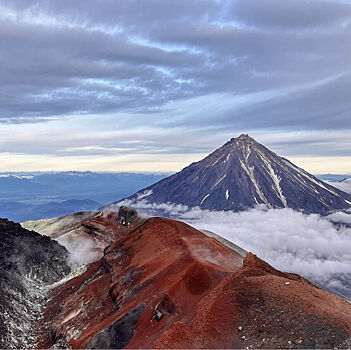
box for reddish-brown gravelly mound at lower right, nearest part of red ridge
[153,253,351,348]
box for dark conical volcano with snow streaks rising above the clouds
[115,135,351,213]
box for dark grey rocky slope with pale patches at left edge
[0,219,71,348]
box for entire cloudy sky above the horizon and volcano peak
[0,0,351,173]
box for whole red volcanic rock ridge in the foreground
[39,217,351,348]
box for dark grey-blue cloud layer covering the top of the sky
[0,0,350,118]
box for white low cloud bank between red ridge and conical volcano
[116,200,351,299]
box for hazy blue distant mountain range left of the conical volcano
[0,171,168,222]
